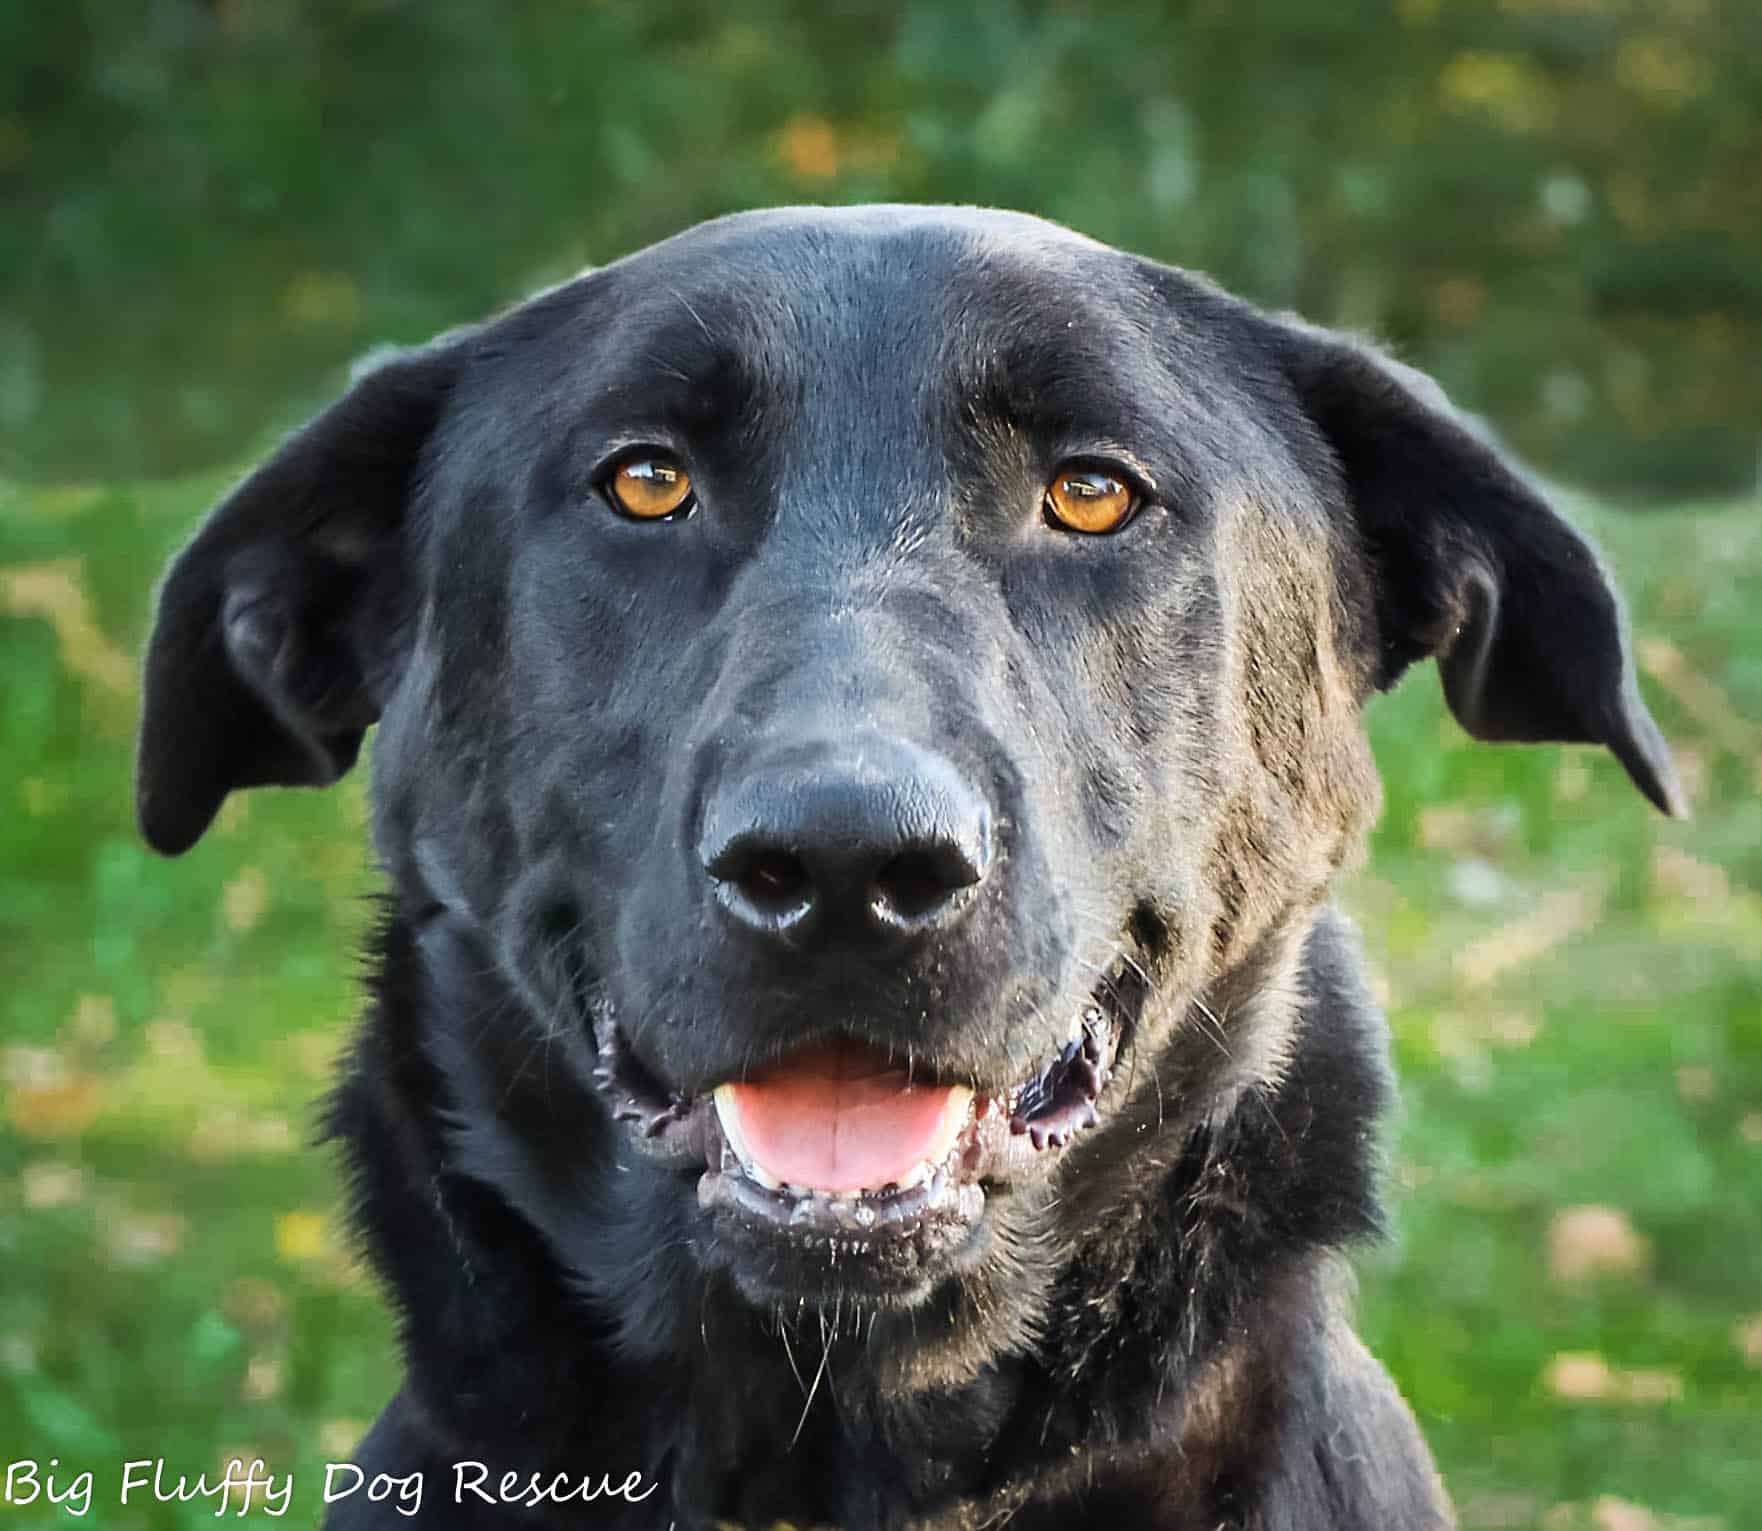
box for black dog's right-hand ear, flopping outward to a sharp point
[1279,321,1688,817]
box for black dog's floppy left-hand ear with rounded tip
[136,335,469,856]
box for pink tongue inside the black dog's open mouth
[733,1043,953,1191]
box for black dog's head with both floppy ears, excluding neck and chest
[139,208,1679,1325]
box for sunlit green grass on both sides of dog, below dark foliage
[0,479,1762,1531]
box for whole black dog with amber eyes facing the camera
[139,208,1679,1531]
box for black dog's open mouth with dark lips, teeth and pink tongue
[594,955,1149,1247]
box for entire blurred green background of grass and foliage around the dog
[0,0,1762,1531]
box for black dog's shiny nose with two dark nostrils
[700,738,990,939]
